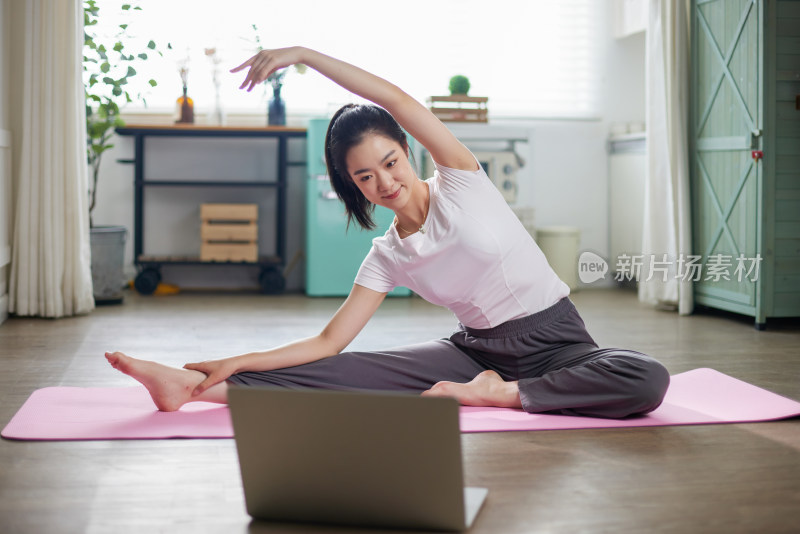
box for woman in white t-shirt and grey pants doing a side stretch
[106,47,669,418]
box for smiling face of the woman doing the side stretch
[345,134,417,211]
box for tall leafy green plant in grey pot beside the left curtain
[83,0,160,304]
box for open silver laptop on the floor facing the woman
[228,386,487,530]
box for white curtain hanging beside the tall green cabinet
[639,0,694,314]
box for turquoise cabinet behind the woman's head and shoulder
[306,119,411,297]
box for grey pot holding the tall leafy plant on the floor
[91,226,128,304]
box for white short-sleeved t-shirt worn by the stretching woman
[355,157,569,328]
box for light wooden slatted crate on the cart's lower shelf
[200,204,258,262]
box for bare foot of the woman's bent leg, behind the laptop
[422,370,522,408]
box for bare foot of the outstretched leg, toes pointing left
[106,352,206,412]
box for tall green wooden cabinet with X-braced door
[690,0,800,328]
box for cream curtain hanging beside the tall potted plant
[9,0,94,317]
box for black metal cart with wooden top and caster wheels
[116,125,306,295]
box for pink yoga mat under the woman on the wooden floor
[0,369,800,440]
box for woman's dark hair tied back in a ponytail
[325,104,408,230]
